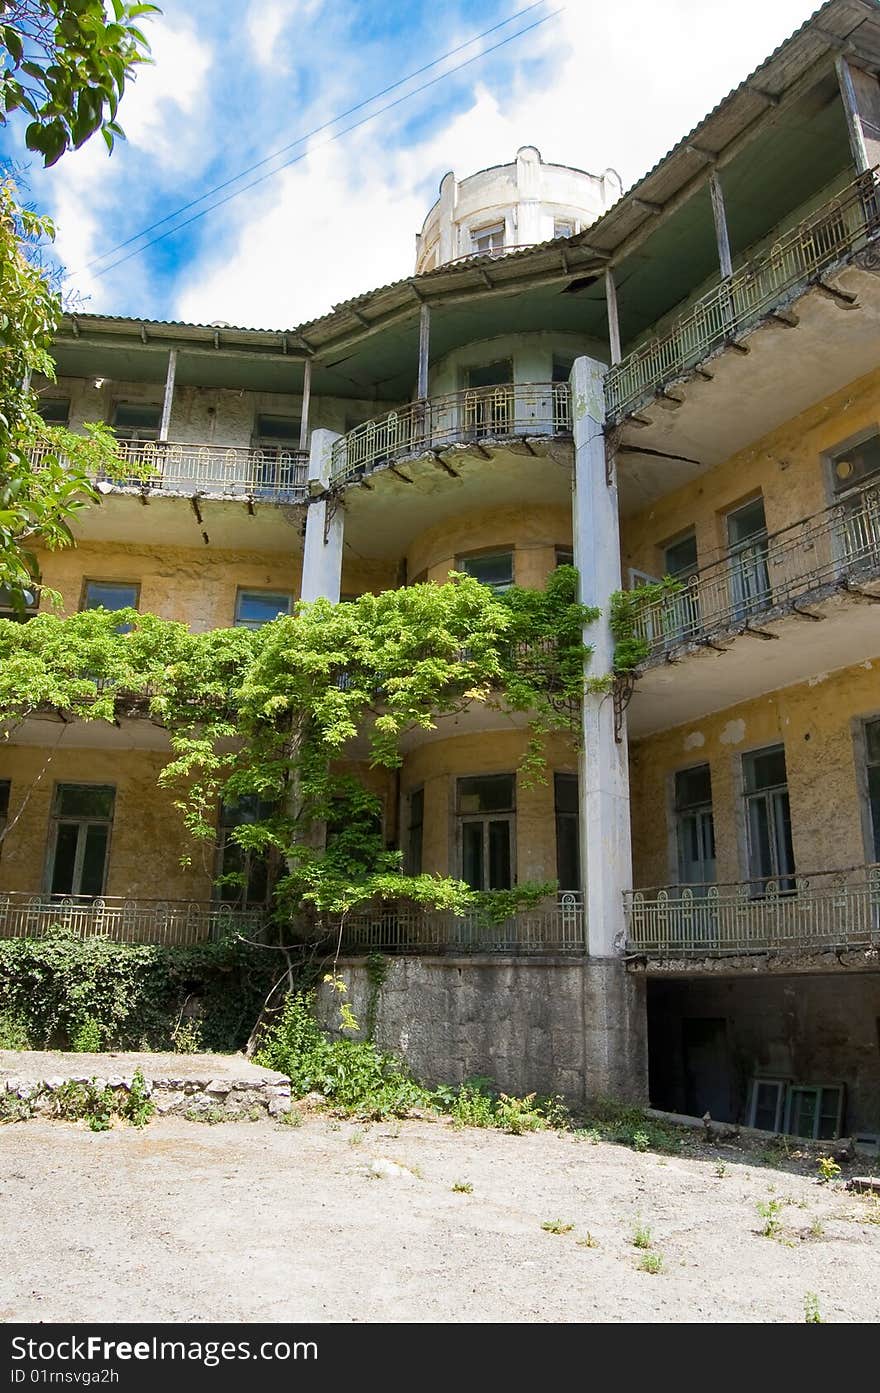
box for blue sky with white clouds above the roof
[0,0,816,329]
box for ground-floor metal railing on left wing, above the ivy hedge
[0,892,266,946]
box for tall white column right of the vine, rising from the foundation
[571,358,632,957]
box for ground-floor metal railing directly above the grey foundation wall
[341,892,586,957]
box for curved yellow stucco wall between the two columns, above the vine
[407,504,571,588]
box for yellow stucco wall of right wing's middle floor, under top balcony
[621,369,880,584]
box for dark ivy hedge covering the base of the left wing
[0,931,274,1050]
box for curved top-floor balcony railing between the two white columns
[330,382,571,488]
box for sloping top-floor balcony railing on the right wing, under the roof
[604,169,880,421]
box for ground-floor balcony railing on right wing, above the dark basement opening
[624,864,880,958]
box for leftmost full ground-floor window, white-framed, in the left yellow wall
[47,784,116,897]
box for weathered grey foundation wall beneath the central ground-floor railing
[317,957,647,1106]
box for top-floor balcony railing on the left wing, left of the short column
[32,440,309,503]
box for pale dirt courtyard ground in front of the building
[0,1114,880,1322]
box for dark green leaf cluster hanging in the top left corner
[0,0,159,164]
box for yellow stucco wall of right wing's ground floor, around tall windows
[631,662,880,886]
